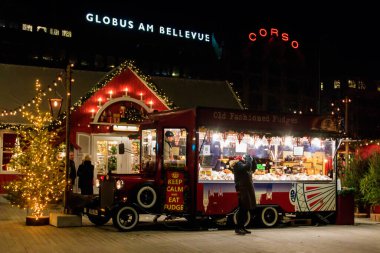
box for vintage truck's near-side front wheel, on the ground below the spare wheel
[112,206,139,231]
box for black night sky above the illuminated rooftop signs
[0,0,380,80]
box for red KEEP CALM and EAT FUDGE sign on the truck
[164,171,184,212]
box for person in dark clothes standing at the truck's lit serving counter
[231,155,256,235]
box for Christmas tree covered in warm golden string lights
[6,80,65,219]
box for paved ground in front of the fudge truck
[0,197,380,253]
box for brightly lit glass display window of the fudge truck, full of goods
[198,129,335,181]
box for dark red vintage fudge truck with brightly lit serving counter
[85,107,338,231]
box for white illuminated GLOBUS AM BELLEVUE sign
[86,13,211,42]
